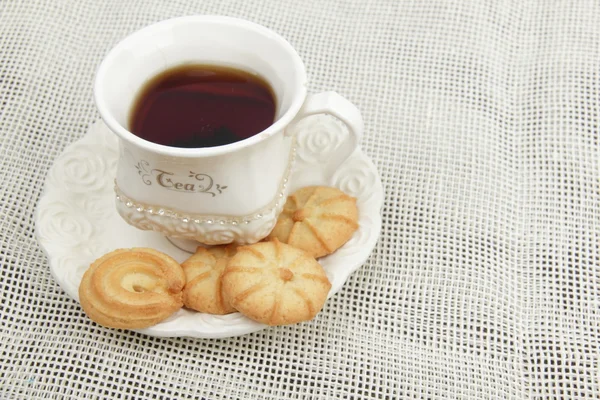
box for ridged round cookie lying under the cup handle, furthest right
[268,186,358,258]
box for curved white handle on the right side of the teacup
[295,92,364,172]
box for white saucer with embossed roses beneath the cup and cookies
[35,116,383,338]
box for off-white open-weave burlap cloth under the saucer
[0,0,600,399]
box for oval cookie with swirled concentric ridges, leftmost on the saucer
[79,248,185,329]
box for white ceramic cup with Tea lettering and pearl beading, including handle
[94,16,363,244]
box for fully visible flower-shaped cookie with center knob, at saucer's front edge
[223,240,331,325]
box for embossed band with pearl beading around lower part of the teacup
[114,135,296,242]
